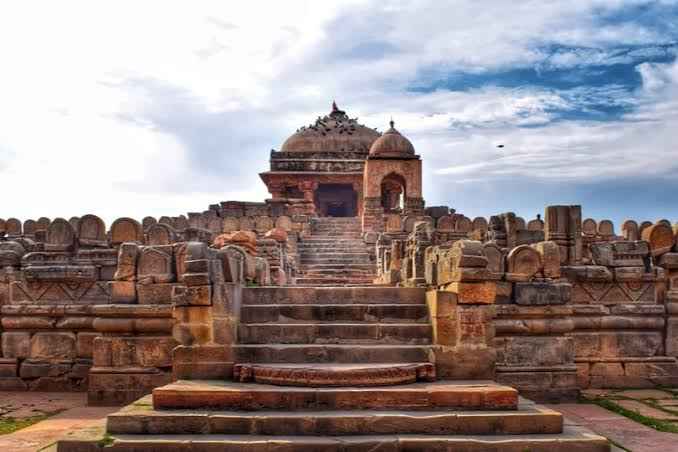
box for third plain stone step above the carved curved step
[240,304,428,323]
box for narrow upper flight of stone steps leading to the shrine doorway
[297,217,376,286]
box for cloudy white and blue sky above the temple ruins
[0,0,678,225]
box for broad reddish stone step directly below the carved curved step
[153,380,518,411]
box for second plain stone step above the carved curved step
[238,323,431,345]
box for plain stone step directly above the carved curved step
[233,344,430,364]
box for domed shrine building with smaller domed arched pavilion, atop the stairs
[260,103,424,230]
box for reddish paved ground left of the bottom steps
[0,392,119,452]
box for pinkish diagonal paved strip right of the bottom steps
[549,403,678,452]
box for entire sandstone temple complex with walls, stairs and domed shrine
[0,105,678,452]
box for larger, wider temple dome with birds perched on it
[281,103,381,154]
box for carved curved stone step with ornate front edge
[233,363,436,388]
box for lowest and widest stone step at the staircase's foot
[57,425,610,452]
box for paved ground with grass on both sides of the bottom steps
[0,388,678,452]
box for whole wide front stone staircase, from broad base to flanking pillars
[58,287,609,452]
